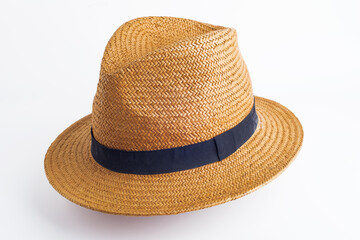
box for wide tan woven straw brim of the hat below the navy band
[45,97,303,215]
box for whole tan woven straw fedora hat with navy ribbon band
[45,17,303,215]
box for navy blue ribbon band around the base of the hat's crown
[91,103,258,174]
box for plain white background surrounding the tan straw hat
[0,0,360,240]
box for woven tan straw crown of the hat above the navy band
[92,17,254,151]
